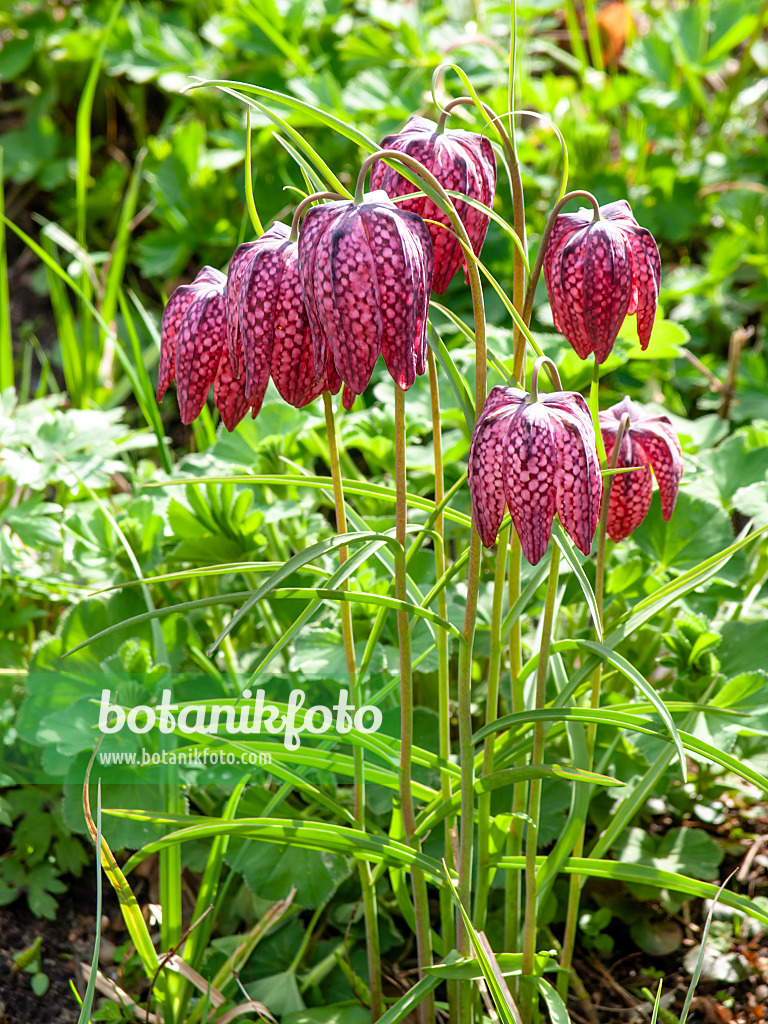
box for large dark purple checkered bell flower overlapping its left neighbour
[298,191,432,404]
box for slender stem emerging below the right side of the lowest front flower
[520,543,560,1024]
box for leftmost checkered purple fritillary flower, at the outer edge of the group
[158,266,249,430]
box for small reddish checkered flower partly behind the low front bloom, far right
[599,398,683,541]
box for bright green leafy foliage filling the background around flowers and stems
[0,0,768,1024]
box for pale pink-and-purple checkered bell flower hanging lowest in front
[469,359,603,565]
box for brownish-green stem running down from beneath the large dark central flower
[394,385,435,1024]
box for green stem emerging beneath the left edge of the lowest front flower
[474,526,510,931]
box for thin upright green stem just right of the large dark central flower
[427,348,459,1024]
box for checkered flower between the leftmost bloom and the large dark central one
[226,223,341,416]
